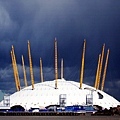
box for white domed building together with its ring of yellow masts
[0,40,120,110]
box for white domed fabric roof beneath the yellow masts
[0,79,120,110]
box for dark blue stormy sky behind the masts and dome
[0,0,120,101]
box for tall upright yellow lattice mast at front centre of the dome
[54,38,58,89]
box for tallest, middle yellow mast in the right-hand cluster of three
[96,44,105,89]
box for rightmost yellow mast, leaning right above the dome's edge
[101,49,110,91]
